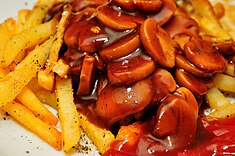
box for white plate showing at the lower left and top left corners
[0,0,99,156]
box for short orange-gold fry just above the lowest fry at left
[16,87,58,126]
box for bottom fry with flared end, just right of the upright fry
[79,113,115,154]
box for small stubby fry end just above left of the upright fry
[38,70,55,90]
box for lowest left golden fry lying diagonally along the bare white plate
[2,102,62,150]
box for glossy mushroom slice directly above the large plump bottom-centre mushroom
[108,55,155,85]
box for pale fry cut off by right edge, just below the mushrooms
[213,74,235,93]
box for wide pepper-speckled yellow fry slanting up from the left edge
[0,39,53,107]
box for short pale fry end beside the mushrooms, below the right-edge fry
[206,87,231,110]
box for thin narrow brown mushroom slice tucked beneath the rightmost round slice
[175,69,207,95]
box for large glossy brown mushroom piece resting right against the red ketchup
[153,94,197,149]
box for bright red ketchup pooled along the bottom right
[104,118,235,156]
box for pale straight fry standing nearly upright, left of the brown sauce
[56,76,81,152]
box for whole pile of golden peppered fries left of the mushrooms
[0,0,114,153]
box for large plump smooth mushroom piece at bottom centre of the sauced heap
[95,79,153,126]
